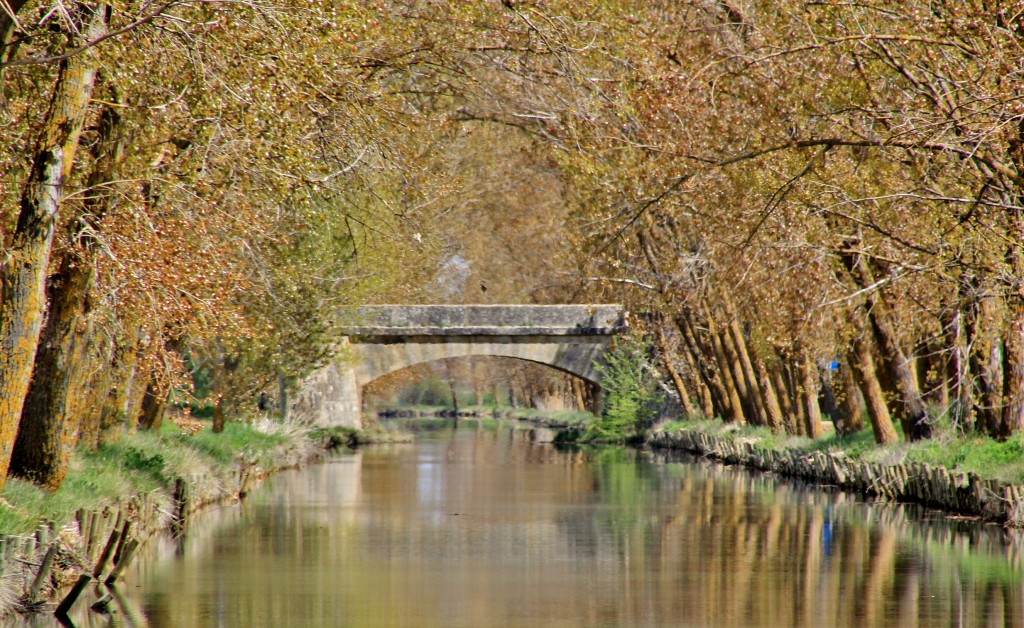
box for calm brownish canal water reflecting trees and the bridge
[54,420,1024,628]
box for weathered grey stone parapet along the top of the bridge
[341,304,628,340]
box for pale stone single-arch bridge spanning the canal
[292,305,626,427]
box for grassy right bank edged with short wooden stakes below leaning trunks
[645,415,1024,528]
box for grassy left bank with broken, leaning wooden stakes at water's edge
[0,420,408,623]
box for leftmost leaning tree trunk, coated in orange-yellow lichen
[0,4,109,489]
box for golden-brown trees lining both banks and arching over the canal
[6,0,1024,532]
